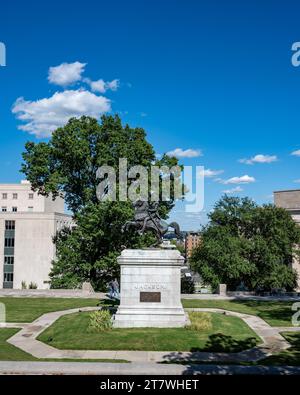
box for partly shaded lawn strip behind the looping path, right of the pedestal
[182,299,295,326]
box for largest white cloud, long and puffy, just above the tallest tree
[12,89,111,137]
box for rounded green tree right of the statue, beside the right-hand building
[191,195,300,290]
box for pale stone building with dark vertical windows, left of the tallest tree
[0,181,73,289]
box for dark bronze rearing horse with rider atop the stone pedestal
[122,200,182,246]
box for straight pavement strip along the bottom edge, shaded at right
[0,361,300,376]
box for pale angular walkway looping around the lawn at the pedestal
[7,307,300,363]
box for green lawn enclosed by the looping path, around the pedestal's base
[38,312,260,352]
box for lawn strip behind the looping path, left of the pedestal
[0,297,115,322]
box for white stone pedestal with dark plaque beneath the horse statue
[114,248,188,328]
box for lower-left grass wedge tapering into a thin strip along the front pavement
[0,328,128,363]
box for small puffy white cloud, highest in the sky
[48,62,86,87]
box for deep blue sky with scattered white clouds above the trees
[0,0,300,229]
